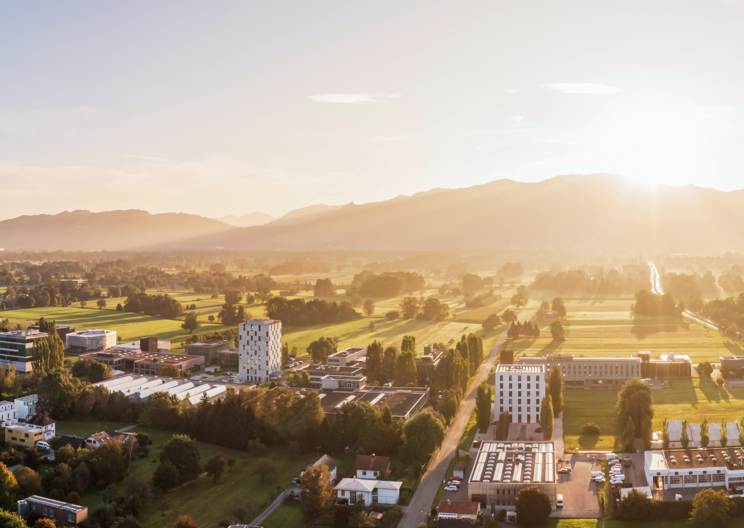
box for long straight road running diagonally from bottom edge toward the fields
[398,330,506,528]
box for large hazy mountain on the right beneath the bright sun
[183,175,744,254]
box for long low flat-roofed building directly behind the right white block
[514,354,641,389]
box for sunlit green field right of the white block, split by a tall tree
[563,378,744,450]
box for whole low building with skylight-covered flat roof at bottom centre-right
[468,441,556,509]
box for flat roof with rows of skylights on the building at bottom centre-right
[470,441,555,484]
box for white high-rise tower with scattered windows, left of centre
[238,319,282,384]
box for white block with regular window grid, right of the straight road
[493,365,545,423]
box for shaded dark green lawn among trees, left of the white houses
[82,426,313,528]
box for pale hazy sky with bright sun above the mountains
[0,0,744,218]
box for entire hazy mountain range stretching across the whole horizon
[0,175,744,254]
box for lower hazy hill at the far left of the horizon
[0,210,238,250]
